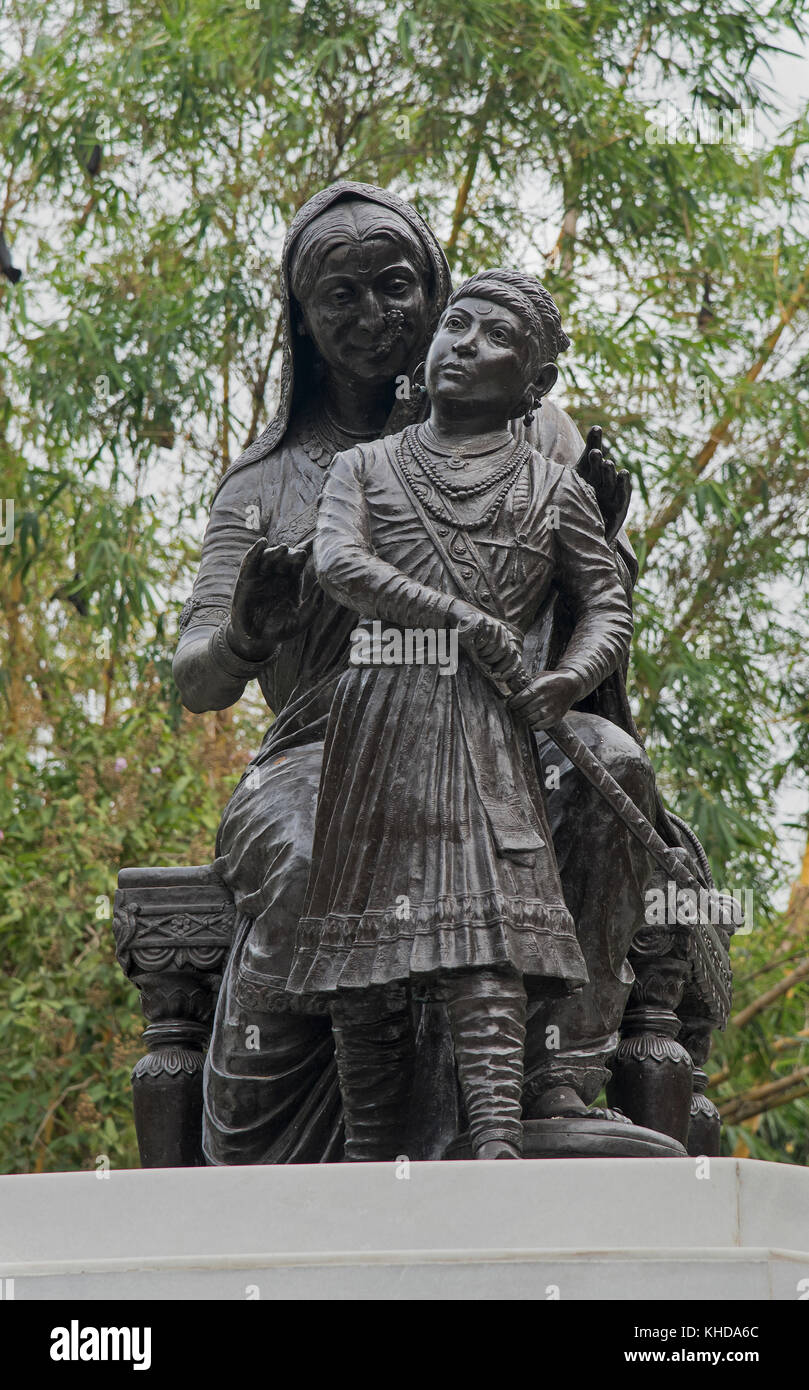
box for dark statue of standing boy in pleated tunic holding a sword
[288,270,632,1161]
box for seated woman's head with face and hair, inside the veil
[289,197,436,382]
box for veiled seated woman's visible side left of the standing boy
[174,182,455,1163]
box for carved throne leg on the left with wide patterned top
[113,865,235,1168]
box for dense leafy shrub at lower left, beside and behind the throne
[0,678,255,1172]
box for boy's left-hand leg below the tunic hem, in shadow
[331,987,416,1163]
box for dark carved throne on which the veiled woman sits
[113,865,733,1168]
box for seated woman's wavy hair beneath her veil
[289,197,434,303]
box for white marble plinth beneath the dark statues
[0,1158,809,1301]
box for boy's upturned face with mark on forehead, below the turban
[424,296,532,420]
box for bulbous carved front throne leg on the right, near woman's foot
[607,927,692,1145]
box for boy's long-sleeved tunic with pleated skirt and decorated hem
[288,435,632,995]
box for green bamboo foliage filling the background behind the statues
[0,0,809,1169]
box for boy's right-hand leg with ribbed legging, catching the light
[442,970,525,1158]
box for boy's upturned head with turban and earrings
[425,270,570,420]
